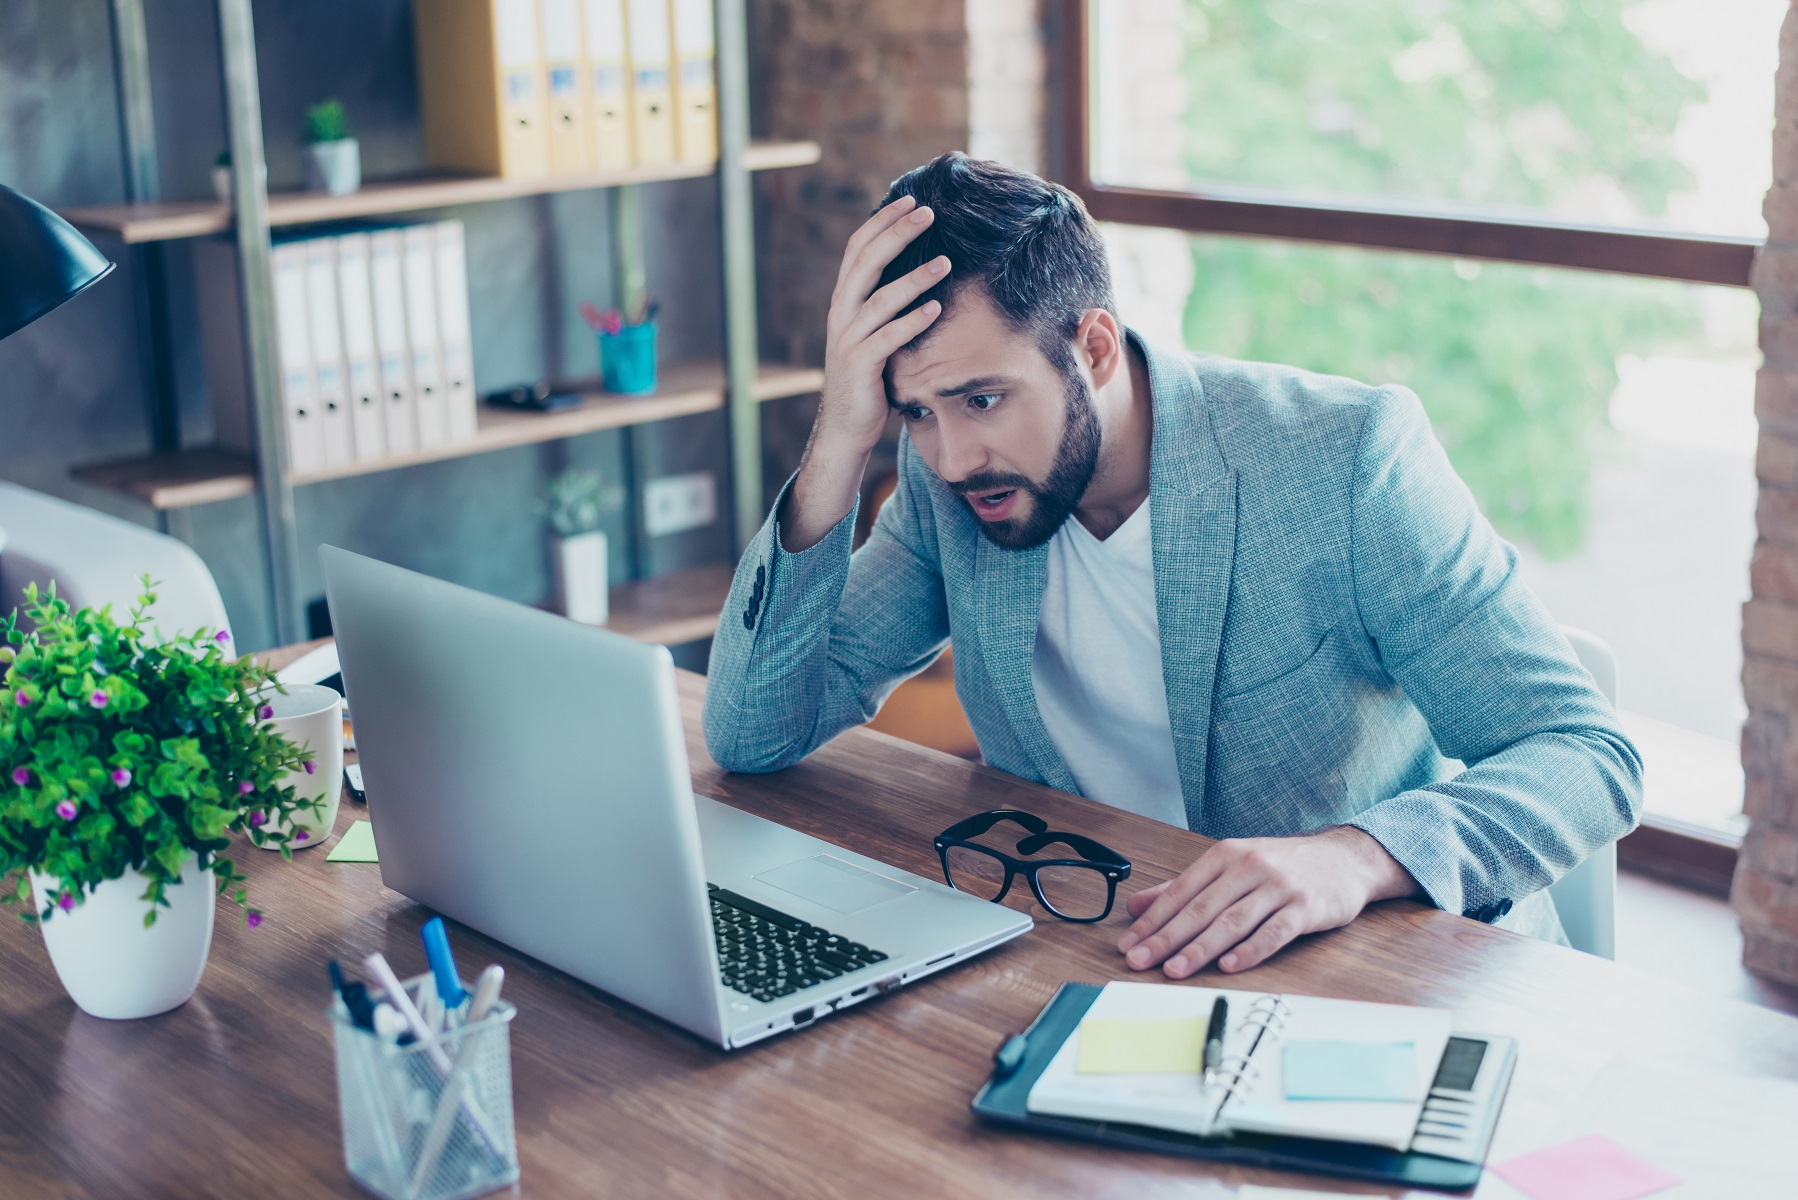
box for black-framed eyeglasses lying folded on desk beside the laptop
[937,808,1129,921]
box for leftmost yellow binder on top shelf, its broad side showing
[414,0,550,178]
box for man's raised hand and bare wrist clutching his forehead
[780,196,949,552]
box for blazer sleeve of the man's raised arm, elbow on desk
[705,443,949,772]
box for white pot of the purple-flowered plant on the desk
[31,855,218,1020]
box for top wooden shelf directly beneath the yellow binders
[58,142,822,243]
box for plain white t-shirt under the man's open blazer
[1030,500,1187,829]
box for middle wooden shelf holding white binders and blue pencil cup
[74,362,823,509]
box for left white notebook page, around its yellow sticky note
[1025,982,1264,1137]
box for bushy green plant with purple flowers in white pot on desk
[0,578,313,1018]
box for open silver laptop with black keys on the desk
[320,545,1032,1049]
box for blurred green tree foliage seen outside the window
[1185,0,1705,556]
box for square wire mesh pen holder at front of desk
[331,975,518,1200]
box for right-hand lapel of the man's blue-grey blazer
[1129,333,1237,833]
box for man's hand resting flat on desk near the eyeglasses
[1118,826,1417,979]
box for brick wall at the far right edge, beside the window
[1731,0,1798,982]
